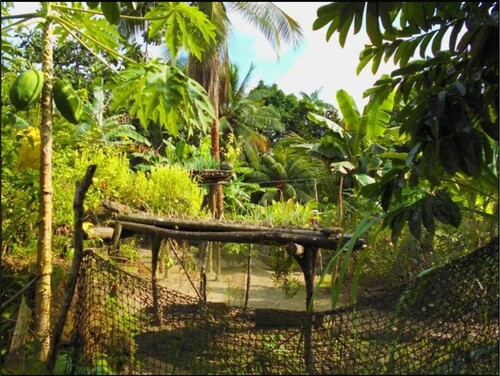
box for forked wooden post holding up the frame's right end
[286,243,318,375]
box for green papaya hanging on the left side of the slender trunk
[9,69,44,110]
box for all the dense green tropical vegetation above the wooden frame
[1,2,499,374]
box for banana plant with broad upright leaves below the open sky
[287,90,401,222]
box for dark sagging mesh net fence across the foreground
[67,239,499,375]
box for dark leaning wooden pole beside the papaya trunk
[45,165,97,375]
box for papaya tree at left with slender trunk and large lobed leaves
[2,2,214,360]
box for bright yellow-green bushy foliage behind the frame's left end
[54,148,209,229]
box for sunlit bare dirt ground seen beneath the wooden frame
[143,248,340,311]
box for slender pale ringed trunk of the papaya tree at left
[35,12,54,361]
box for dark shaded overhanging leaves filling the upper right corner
[313,2,499,241]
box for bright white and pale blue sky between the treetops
[8,1,395,111]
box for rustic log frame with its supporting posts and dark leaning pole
[46,165,364,374]
